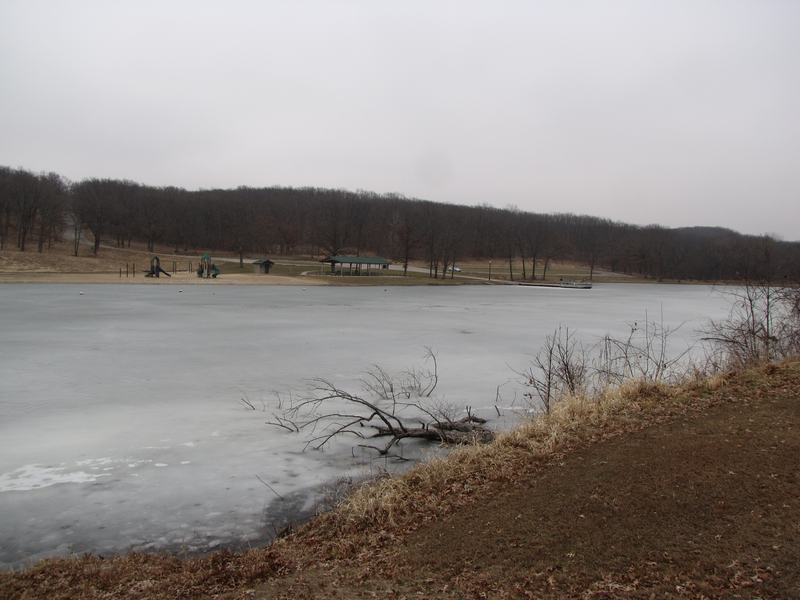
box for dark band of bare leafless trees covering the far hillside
[0,166,800,281]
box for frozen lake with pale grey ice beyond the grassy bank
[0,284,728,569]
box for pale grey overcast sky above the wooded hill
[0,0,800,240]
